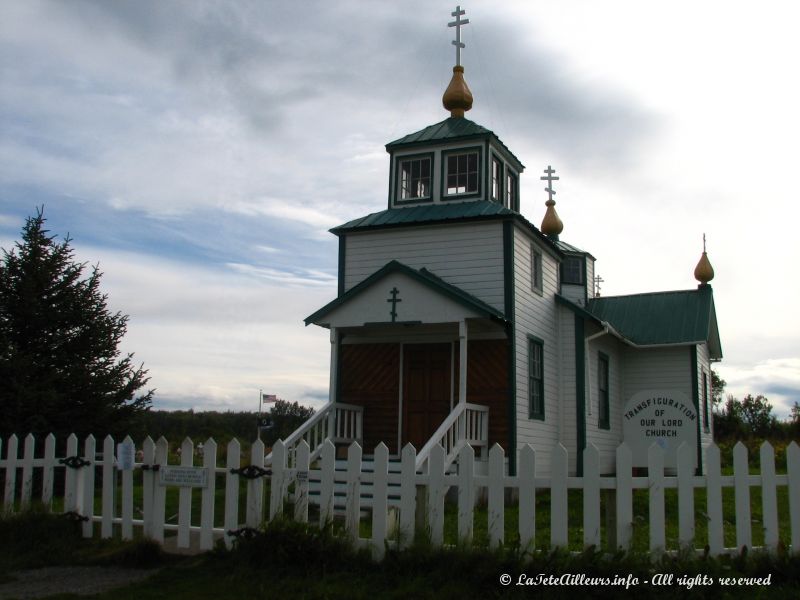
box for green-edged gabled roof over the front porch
[304,260,506,327]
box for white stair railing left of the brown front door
[264,402,364,465]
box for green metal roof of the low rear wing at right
[587,286,722,358]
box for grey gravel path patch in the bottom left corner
[0,567,158,600]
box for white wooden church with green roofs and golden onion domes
[287,9,722,474]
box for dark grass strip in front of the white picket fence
[0,513,800,600]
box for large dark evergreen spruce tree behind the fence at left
[0,210,153,440]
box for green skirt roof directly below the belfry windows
[330,200,564,258]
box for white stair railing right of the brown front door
[417,402,489,472]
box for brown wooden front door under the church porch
[401,343,453,451]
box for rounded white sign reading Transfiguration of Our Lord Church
[622,390,697,469]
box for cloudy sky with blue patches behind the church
[0,0,800,416]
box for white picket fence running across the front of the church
[0,435,800,556]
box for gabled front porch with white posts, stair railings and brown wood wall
[274,261,510,469]
